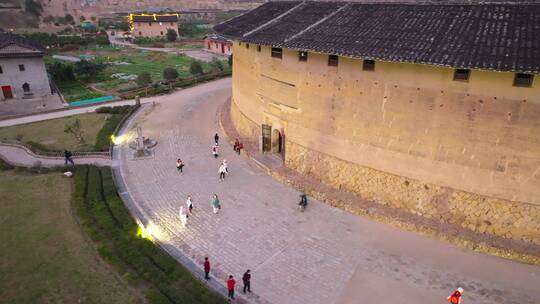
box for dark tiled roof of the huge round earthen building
[214,0,540,73]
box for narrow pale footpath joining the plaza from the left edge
[0,143,111,167]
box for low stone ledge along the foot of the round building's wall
[217,98,540,265]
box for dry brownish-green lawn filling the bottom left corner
[0,170,141,304]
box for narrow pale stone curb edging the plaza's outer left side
[111,104,255,304]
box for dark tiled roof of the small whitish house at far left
[0,33,45,57]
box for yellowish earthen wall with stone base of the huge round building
[231,44,540,242]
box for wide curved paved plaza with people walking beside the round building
[115,79,540,304]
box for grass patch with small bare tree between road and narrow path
[0,113,111,151]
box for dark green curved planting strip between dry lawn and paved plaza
[73,166,225,304]
